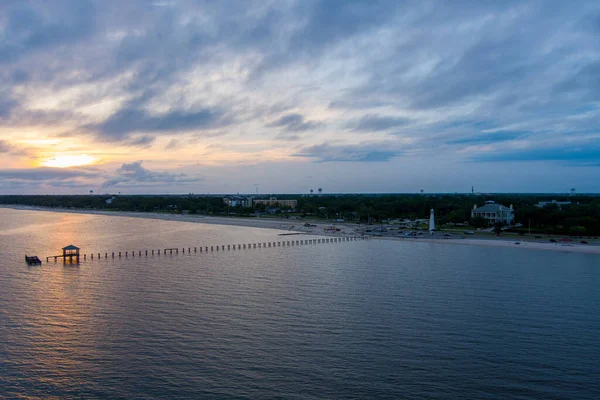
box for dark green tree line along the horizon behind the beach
[0,194,600,235]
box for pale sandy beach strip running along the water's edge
[0,205,600,255]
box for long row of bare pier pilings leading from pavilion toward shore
[68,236,367,261]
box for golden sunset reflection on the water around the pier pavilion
[0,209,328,394]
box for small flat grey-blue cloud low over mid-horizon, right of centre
[294,143,400,162]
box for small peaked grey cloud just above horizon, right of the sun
[102,161,202,187]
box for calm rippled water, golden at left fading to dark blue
[0,209,600,399]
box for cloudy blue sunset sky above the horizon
[0,0,600,194]
